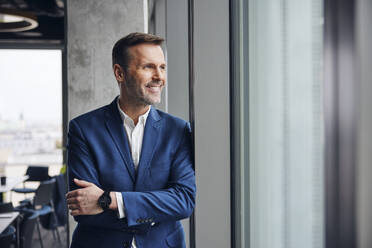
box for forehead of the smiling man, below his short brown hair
[129,44,165,64]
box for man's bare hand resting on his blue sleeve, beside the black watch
[66,178,103,216]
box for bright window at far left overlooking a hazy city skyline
[0,49,62,196]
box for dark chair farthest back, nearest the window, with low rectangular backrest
[12,165,50,197]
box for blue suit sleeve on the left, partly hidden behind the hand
[67,120,123,228]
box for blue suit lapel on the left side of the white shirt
[106,98,135,182]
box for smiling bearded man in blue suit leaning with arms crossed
[66,33,196,248]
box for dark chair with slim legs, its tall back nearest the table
[18,178,61,248]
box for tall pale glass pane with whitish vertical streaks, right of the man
[235,0,324,248]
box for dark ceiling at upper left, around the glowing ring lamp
[0,0,65,44]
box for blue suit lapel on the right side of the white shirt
[136,107,161,185]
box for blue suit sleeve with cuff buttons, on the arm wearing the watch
[122,123,196,226]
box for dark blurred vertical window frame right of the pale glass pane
[324,0,359,248]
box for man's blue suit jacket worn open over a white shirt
[67,99,196,248]
